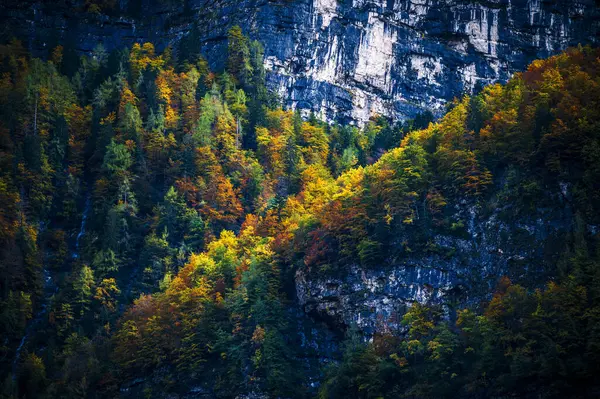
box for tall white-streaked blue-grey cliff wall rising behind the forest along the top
[0,0,600,124]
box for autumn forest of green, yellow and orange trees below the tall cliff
[0,27,600,398]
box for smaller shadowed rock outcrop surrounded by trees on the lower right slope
[296,198,576,335]
